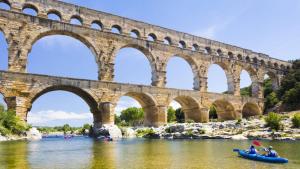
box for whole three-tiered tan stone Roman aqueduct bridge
[0,0,291,126]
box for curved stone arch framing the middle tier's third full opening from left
[163,54,200,90]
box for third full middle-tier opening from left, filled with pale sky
[166,56,196,90]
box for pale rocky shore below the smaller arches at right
[122,118,300,140]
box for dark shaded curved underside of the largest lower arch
[26,85,99,119]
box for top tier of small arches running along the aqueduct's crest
[0,0,290,70]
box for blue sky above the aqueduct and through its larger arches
[0,0,300,126]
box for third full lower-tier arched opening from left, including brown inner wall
[168,96,206,123]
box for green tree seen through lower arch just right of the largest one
[120,107,144,126]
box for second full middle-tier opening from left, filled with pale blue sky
[114,47,152,85]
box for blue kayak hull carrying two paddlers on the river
[233,149,288,163]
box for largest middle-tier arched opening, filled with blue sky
[27,35,98,80]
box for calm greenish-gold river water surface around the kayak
[0,137,300,169]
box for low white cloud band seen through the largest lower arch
[28,110,93,124]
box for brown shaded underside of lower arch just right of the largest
[121,92,159,126]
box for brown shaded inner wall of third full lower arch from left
[173,96,208,122]
